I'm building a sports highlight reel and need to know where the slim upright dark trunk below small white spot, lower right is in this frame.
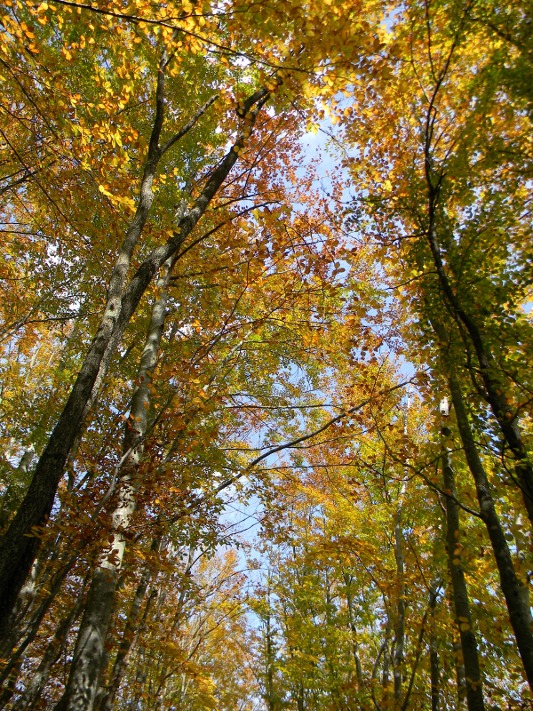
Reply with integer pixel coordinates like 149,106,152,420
442,427,485,711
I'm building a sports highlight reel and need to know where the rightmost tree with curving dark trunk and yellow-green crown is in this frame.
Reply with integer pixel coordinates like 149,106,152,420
340,3,533,696
